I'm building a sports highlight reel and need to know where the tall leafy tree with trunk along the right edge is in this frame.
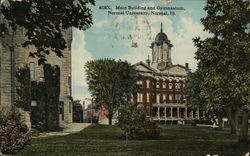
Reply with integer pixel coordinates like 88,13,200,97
194,0,250,143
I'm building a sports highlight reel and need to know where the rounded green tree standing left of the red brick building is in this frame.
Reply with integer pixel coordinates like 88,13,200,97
85,59,140,125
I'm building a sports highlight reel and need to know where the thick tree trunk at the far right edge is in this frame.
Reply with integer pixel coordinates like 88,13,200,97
239,109,249,143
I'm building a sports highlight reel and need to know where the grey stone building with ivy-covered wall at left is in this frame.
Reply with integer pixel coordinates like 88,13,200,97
0,28,72,122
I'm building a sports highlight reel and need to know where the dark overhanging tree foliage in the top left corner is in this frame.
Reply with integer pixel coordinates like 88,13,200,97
0,0,94,64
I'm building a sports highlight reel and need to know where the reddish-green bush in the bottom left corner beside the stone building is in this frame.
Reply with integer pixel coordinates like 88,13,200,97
0,120,29,153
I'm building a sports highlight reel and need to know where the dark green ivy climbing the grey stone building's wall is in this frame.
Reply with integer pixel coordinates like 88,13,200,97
16,64,60,131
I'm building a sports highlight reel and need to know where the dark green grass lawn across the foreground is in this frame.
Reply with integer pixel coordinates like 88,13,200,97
17,125,248,156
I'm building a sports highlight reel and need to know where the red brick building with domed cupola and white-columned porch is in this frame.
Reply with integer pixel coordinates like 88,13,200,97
132,25,205,123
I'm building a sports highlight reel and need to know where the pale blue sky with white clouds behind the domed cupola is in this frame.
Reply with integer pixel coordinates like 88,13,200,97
72,0,208,104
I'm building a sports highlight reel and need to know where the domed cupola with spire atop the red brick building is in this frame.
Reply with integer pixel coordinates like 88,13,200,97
150,23,173,71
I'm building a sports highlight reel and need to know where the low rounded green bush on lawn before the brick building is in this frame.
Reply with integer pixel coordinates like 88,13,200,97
118,104,160,139
